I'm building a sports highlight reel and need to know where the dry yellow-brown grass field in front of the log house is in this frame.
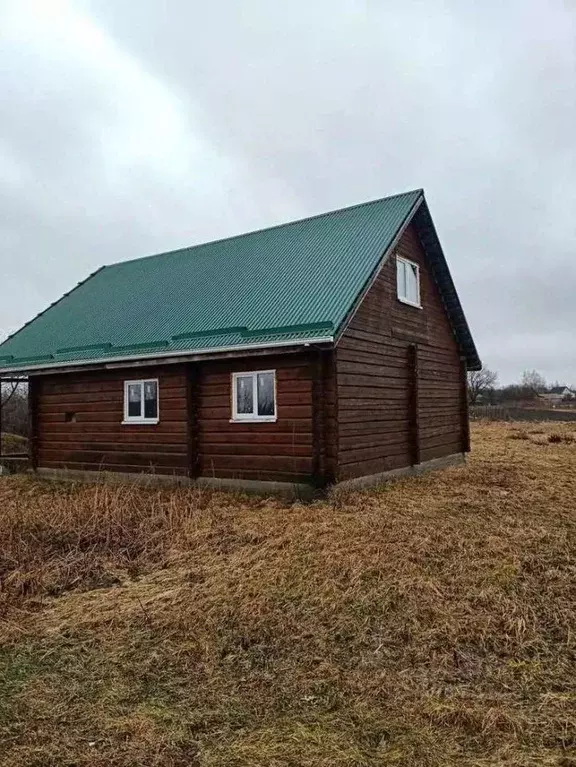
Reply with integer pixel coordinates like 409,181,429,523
0,423,576,767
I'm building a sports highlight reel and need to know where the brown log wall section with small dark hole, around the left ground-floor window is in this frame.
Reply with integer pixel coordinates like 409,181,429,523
31,365,188,474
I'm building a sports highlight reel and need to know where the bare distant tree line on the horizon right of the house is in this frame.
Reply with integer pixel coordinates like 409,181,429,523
468,368,576,405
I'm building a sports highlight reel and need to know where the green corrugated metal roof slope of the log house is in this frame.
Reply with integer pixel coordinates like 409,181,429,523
0,190,422,370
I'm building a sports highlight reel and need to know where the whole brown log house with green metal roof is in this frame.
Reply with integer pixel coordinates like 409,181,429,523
0,190,481,490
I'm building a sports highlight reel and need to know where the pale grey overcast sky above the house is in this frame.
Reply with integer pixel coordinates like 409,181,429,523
0,0,576,384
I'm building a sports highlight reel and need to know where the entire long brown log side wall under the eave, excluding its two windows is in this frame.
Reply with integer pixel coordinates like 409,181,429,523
34,352,322,482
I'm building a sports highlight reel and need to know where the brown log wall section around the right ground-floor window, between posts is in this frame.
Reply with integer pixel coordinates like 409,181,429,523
197,352,318,482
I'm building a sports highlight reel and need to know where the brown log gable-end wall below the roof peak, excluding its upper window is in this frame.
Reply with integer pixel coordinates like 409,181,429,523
336,219,467,479
